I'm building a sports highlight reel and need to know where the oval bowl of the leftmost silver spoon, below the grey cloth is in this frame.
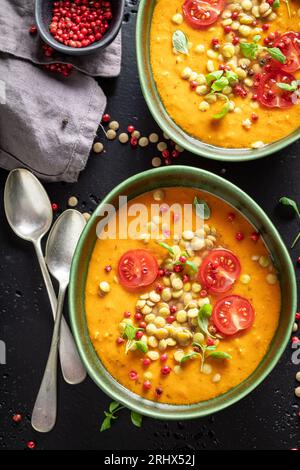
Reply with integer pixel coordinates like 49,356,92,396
4,168,53,242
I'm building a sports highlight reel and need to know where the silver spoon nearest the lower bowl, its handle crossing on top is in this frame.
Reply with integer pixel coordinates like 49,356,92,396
31,209,85,432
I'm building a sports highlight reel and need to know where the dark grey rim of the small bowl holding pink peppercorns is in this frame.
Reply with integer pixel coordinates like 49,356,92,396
34,0,125,56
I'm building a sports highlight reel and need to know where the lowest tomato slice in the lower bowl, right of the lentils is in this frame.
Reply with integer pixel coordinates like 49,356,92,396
212,295,255,336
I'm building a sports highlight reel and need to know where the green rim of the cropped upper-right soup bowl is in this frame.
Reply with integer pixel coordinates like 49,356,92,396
136,0,300,162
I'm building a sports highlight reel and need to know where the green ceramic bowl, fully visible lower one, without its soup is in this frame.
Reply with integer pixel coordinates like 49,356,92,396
69,166,296,419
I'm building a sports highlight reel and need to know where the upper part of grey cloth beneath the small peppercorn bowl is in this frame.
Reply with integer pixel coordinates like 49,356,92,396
0,0,121,77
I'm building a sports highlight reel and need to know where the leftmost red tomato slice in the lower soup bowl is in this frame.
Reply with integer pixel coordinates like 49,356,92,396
118,250,158,289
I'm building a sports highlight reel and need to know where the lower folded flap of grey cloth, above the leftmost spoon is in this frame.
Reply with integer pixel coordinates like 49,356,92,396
0,53,106,182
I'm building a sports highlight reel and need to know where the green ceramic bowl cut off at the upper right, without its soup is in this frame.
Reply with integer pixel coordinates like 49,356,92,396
136,0,300,162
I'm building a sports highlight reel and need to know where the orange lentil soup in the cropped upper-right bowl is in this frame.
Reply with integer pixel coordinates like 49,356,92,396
150,0,300,148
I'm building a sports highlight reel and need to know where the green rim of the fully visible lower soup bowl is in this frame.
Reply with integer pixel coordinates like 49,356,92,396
69,165,297,420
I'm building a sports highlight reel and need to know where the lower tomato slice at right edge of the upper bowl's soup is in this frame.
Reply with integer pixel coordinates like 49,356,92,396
257,68,295,108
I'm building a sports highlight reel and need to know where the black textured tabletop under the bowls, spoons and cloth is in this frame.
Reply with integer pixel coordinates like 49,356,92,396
0,0,300,450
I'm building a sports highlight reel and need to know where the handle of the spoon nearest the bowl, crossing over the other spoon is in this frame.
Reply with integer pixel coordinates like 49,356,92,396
31,287,66,432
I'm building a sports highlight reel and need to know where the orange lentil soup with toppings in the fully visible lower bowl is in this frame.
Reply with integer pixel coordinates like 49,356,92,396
85,188,281,404
